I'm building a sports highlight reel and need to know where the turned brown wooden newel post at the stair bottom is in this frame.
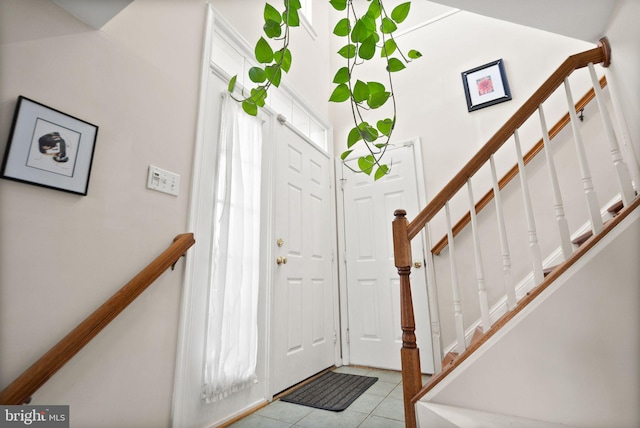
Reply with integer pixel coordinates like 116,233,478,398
393,210,422,428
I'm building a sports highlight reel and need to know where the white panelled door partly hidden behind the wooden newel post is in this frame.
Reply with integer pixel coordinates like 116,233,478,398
342,143,434,373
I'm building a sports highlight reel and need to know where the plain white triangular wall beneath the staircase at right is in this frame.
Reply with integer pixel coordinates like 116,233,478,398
425,209,640,428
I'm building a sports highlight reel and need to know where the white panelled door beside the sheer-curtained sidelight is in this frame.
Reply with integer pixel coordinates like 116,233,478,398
271,125,337,393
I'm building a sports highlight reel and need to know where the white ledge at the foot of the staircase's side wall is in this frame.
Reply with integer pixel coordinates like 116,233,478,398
416,401,567,428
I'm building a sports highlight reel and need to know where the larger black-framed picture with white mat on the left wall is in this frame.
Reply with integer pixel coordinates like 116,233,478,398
0,96,98,195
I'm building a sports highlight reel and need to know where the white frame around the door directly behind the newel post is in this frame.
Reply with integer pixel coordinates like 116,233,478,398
335,137,440,372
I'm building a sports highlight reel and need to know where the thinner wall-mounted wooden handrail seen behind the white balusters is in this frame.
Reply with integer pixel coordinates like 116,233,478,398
431,76,607,256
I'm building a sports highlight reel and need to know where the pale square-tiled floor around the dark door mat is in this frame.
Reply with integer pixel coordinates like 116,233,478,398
231,366,430,428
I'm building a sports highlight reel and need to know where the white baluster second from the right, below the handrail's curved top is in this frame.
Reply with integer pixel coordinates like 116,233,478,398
589,62,635,207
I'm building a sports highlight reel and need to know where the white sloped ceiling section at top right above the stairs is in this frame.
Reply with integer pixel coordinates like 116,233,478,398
422,0,617,42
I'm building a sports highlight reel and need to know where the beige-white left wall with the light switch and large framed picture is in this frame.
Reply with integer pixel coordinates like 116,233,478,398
0,0,205,427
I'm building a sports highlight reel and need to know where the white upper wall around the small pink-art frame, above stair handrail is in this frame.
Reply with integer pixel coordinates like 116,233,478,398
332,2,594,207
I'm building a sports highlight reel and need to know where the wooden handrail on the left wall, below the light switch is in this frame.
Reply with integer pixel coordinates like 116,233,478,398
0,233,196,404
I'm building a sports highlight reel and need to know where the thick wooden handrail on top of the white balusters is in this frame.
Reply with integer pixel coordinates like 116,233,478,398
407,37,611,240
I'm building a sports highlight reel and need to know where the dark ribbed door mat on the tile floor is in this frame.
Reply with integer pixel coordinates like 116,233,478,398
280,372,378,412
